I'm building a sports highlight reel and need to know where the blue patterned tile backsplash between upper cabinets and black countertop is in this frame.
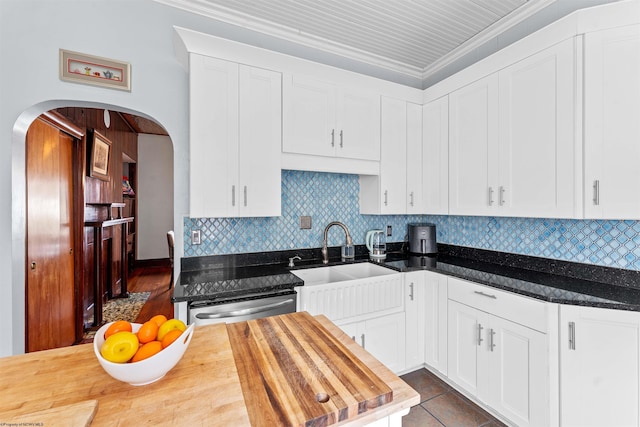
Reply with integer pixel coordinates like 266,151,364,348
184,170,640,270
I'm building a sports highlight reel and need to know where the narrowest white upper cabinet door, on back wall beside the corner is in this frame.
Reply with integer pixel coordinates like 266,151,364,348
408,102,422,214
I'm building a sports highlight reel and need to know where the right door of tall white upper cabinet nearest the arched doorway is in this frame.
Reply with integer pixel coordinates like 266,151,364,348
238,65,282,217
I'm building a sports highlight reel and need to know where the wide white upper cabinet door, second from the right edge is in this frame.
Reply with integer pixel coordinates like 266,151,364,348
495,39,578,218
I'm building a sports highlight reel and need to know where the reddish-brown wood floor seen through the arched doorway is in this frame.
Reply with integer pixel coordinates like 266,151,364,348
127,267,173,323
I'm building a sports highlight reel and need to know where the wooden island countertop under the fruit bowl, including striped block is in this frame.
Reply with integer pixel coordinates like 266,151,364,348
0,312,419,427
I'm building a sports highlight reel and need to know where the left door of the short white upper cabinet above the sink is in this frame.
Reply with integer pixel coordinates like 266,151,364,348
282,75,339,156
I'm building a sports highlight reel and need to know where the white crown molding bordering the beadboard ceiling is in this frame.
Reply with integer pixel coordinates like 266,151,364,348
154,0,557,80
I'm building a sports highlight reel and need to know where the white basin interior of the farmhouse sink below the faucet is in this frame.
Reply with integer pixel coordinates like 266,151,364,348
291,262,397,286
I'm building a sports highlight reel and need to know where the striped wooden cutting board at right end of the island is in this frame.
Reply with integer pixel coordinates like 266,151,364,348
227,312,393,427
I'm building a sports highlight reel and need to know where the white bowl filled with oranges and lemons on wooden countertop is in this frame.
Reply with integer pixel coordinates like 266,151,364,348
93,316,194,386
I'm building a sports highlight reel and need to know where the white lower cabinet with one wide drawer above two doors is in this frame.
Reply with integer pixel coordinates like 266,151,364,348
447,278,550,426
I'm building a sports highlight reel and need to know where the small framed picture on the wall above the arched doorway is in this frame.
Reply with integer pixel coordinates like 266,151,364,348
60,49,131,91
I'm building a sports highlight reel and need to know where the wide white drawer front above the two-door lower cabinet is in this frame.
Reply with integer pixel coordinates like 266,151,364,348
448,277,548,333
